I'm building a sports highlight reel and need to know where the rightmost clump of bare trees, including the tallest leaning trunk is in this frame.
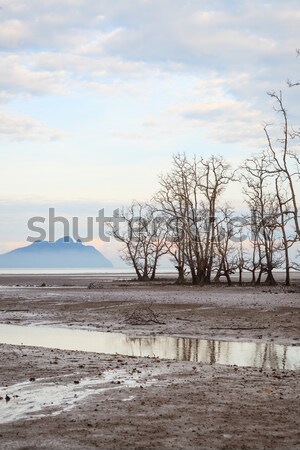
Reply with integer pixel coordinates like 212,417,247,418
242,93,300,285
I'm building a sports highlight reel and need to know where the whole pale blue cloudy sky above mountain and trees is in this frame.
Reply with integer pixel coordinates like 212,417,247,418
0,0,300,264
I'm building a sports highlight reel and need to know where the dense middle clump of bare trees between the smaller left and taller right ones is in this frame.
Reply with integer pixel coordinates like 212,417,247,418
154,155,234,285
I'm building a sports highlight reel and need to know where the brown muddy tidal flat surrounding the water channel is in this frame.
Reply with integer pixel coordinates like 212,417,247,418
0,276,300,450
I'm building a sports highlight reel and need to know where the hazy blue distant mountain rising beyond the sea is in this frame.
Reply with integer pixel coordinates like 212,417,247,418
0,236,113,269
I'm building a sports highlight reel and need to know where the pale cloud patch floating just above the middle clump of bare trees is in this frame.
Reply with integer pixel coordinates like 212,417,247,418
170,73,270,147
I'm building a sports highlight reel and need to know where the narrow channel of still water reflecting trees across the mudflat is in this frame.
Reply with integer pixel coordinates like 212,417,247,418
0,325,300,370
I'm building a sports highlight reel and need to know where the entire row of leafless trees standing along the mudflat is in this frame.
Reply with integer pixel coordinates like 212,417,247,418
111,67,300,285
